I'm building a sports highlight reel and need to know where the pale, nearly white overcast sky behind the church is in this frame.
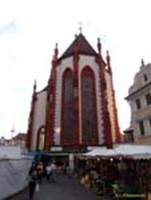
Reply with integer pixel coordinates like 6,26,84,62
0,0,151,138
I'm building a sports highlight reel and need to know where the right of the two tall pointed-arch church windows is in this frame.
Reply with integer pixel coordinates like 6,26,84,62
81,67,97,144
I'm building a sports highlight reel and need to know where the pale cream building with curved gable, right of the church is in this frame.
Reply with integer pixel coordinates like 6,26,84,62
126,60,151,144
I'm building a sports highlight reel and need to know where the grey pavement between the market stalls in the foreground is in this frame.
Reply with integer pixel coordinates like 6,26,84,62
9,174,109,200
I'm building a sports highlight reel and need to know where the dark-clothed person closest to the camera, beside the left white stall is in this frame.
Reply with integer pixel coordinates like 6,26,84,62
29,169,38,200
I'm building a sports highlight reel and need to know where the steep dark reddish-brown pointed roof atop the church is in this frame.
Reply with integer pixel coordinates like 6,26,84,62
60,33,97,59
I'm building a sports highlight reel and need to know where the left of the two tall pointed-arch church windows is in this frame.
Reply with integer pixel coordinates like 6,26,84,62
62,69,73,143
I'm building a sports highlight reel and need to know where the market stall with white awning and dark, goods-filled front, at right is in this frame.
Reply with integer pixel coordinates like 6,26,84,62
76,144,151,199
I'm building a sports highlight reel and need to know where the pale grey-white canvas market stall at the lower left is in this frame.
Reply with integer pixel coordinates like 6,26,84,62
0,146,33,200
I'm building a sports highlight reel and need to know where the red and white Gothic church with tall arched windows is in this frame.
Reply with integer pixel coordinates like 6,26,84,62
27,33,120,152
